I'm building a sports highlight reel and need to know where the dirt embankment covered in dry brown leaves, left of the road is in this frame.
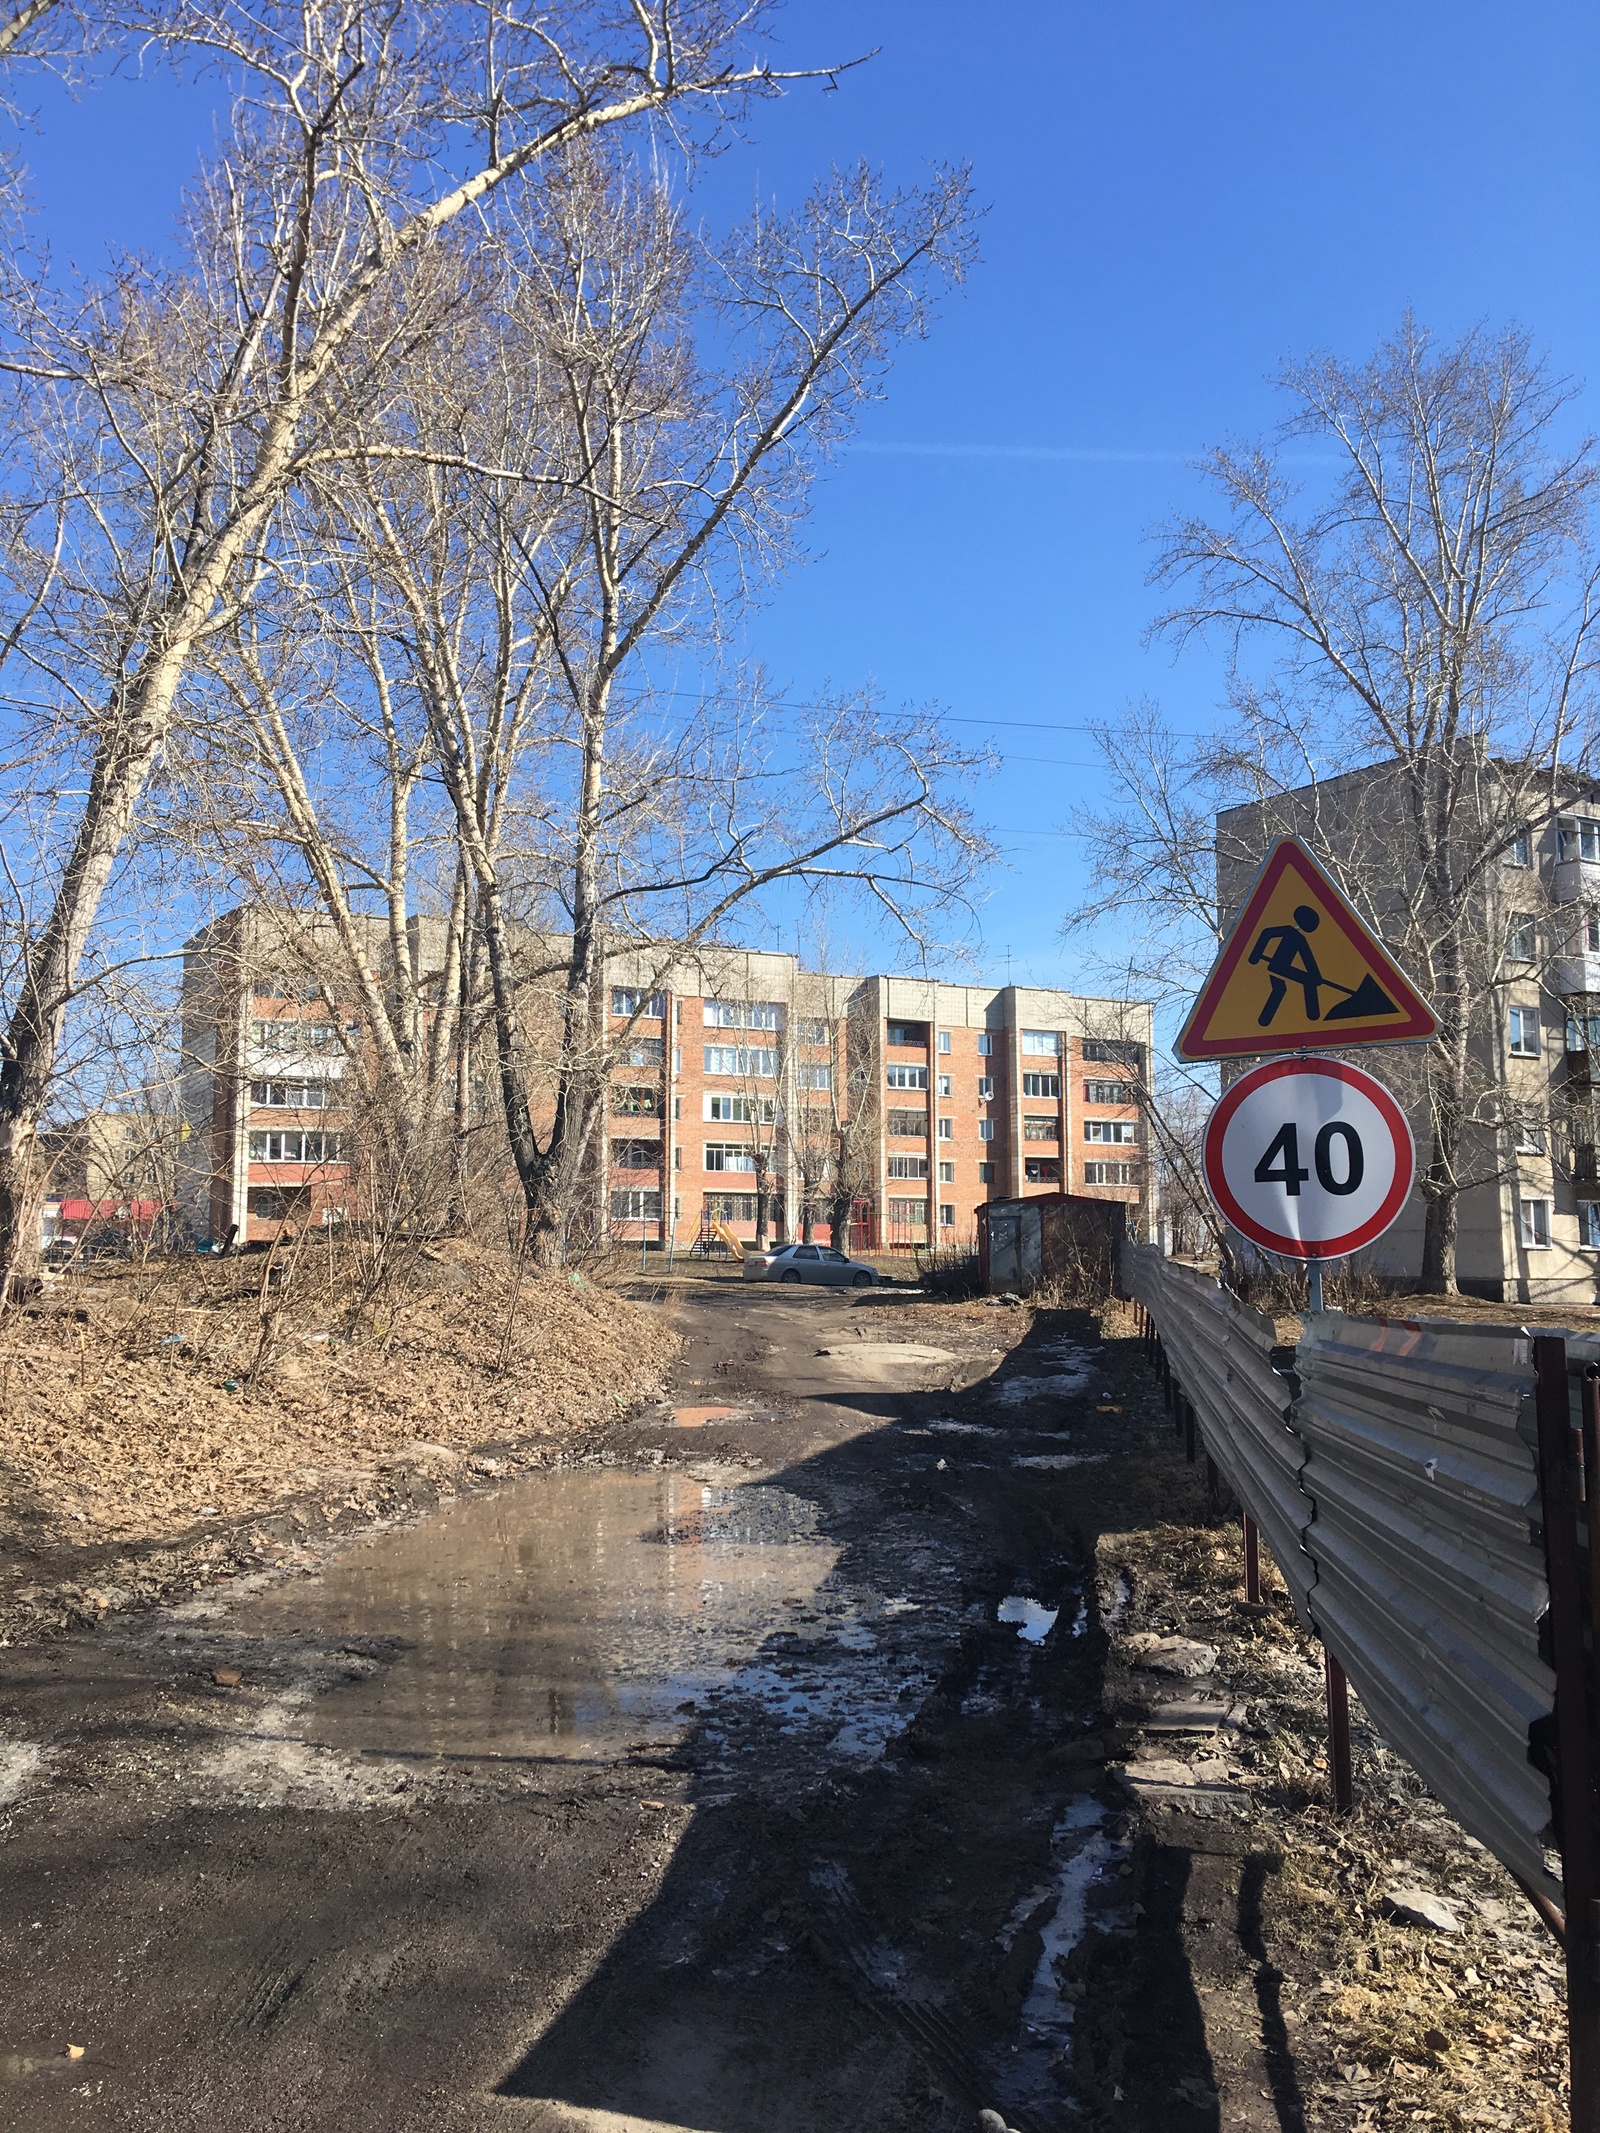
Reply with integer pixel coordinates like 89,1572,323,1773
0,1244,676,1640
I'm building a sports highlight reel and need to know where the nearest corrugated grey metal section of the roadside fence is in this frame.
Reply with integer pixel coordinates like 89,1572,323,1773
1293,1312,1562,1903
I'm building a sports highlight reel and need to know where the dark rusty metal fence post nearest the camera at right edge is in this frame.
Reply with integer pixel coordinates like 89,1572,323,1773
1534,1335,1600,2133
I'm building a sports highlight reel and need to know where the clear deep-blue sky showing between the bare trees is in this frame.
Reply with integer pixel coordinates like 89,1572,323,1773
23,0,1600,983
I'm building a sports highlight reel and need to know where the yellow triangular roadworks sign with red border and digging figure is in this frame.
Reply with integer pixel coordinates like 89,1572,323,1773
1175,836,1438,1060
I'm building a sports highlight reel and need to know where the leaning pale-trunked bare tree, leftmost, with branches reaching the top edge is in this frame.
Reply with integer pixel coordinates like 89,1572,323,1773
0,0,844,1299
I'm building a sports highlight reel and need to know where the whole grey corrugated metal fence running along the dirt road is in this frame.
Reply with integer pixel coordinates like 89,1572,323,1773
1122,1246,1562,1903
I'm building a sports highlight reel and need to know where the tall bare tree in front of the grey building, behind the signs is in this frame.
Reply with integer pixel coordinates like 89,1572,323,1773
1075,320,1600,1293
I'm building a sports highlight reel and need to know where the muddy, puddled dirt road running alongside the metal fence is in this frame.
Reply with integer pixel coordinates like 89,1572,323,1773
0,1280,1562,2133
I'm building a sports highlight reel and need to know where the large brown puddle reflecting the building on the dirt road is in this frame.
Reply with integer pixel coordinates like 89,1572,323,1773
233,1472,838,1760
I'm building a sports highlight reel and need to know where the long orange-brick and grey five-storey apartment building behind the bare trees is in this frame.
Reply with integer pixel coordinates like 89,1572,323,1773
172,911,1152,1250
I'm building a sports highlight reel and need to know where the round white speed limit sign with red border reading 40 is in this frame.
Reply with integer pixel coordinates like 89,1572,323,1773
1203,1058,1417,1258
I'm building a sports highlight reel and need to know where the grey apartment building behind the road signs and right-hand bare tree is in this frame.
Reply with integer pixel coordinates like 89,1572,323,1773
1216,764,1600,1305
